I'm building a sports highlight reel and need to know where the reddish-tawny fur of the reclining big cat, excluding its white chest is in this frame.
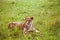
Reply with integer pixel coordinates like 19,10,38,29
8,17,33,32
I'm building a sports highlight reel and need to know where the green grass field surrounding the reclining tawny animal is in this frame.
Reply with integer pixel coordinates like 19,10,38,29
0,0,60,40
